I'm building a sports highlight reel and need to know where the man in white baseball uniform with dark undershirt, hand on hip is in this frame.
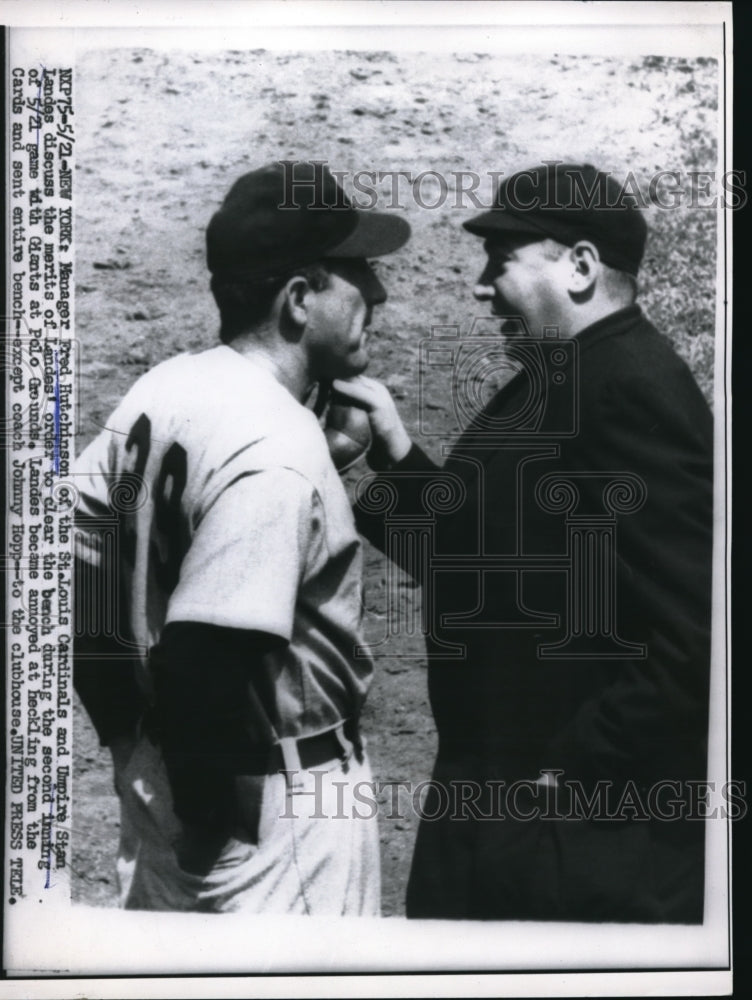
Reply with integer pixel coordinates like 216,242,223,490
75,162,409,915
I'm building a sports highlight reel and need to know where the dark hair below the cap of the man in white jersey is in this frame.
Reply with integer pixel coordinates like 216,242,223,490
210,263,329,344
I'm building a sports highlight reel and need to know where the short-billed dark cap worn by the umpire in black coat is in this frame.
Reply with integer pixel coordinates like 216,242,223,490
463,161,647,275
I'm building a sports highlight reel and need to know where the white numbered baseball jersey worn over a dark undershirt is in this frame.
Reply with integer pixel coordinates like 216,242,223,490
75,345,373,738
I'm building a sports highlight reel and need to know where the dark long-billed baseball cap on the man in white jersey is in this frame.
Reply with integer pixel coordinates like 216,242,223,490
206,160,410,280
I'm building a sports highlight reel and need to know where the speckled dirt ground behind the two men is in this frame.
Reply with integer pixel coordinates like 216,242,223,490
73,48,719,916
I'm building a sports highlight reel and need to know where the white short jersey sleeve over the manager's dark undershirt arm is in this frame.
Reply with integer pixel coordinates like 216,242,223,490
167,469,321,641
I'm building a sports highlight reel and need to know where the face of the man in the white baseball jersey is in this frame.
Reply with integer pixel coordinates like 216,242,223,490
303,259,386,380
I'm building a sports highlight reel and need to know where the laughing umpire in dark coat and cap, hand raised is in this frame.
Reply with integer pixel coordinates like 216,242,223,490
335,164,713,923
